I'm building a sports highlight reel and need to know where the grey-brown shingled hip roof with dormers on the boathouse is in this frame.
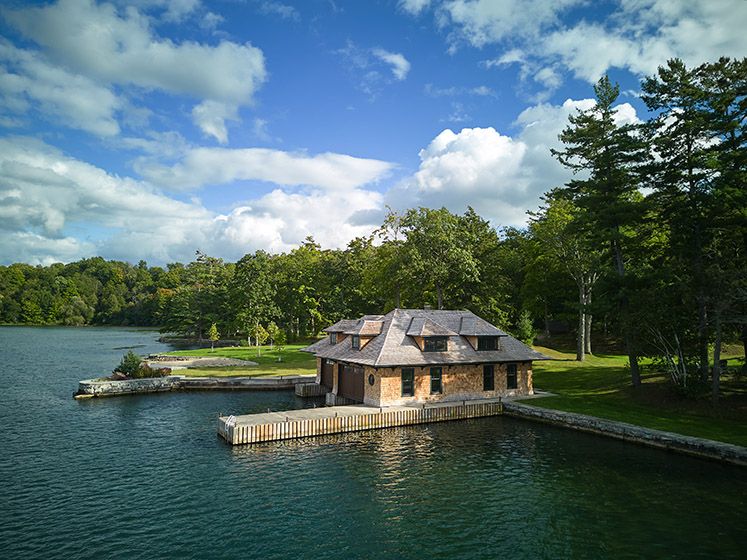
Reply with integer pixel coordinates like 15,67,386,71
303,309,548,367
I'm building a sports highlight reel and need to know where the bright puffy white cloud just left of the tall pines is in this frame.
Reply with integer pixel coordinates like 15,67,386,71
386,99,637,226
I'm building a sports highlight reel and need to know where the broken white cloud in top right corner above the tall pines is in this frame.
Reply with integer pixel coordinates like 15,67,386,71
437,0,747,89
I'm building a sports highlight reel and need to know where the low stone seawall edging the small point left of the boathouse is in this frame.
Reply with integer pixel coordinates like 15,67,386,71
75,375,315,398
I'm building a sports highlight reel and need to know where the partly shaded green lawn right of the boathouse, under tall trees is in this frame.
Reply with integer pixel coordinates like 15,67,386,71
525,347,747,447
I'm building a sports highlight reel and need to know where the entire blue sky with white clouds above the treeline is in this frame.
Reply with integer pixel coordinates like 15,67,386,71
0,0,747,265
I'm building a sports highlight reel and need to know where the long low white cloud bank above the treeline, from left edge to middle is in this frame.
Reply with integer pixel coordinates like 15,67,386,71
0,138,392,264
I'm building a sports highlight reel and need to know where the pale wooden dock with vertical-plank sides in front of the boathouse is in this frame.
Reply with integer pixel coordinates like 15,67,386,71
218,399,503,445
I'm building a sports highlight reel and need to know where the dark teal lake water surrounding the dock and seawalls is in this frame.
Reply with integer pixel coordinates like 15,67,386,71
0,327,747,559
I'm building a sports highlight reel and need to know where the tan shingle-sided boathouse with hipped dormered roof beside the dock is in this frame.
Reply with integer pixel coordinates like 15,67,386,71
304,309,547,406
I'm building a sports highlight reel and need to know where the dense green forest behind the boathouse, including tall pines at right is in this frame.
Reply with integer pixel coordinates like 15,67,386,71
0,54,747,391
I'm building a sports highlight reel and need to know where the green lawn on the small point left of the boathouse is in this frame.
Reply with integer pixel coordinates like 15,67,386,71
168,344,316,377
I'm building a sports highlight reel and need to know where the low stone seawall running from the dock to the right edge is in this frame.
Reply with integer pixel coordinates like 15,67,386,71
503,401,747,466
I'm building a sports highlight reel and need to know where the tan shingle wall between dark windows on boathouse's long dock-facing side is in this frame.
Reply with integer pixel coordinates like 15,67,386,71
363,362,533,406
